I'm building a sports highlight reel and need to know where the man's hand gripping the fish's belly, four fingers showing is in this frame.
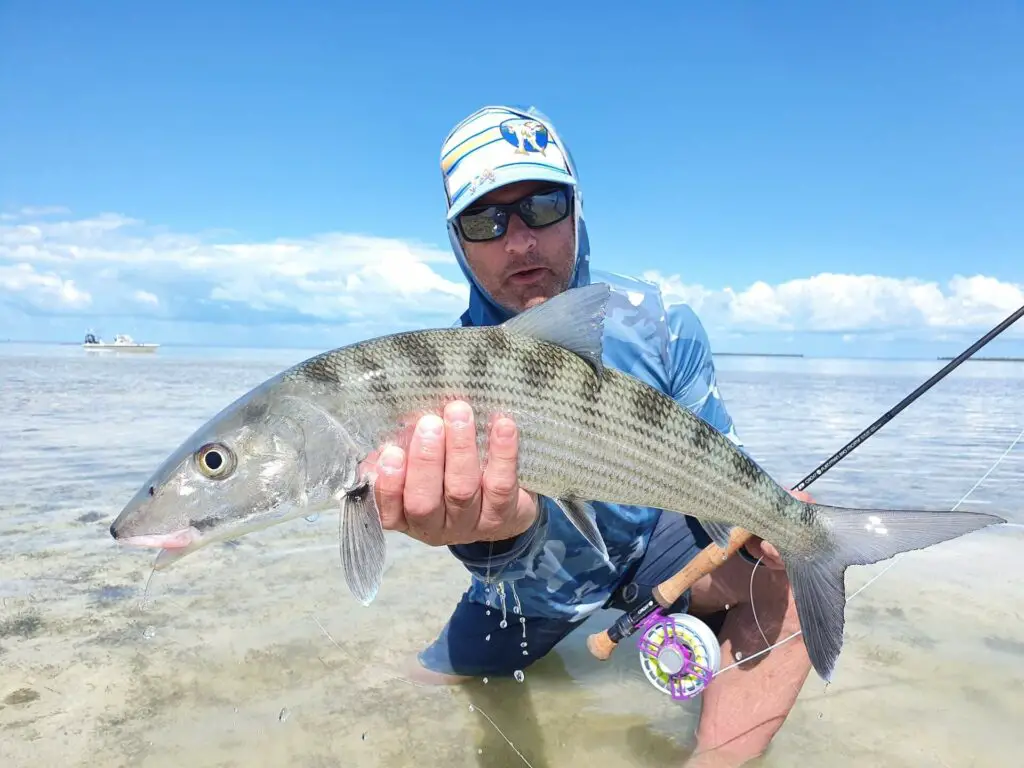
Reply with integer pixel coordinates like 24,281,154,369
371,401,538,546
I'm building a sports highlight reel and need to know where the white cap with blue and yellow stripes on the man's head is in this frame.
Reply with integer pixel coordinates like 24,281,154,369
440,106,577,221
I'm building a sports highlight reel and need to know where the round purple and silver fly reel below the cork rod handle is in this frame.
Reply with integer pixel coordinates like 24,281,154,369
637,609,722,701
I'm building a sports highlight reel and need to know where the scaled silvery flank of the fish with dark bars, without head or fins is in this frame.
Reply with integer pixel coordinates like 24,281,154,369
295,328,799,540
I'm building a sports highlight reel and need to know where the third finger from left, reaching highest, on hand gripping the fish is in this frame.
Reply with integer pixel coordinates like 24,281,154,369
444,401,480,535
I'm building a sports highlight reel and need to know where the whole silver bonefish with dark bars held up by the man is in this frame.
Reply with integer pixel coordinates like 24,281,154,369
111,284,1006,680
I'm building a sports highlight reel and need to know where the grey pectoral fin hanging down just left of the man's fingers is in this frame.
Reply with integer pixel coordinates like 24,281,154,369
338,481,387,605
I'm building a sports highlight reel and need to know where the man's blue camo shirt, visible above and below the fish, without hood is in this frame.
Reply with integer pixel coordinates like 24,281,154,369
450,273,741,621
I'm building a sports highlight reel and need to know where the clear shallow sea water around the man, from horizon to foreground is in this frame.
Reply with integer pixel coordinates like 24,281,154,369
0,344,1024,768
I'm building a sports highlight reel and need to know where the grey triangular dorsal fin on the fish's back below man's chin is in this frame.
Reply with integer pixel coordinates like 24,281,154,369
502,283,611,375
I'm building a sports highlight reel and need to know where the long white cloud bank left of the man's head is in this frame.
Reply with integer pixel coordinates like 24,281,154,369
0,208,468,333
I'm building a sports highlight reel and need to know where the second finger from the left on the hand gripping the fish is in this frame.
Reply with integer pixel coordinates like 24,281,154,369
403,414,444,544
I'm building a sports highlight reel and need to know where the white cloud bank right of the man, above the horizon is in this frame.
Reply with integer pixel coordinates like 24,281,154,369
644,271,1024,340
